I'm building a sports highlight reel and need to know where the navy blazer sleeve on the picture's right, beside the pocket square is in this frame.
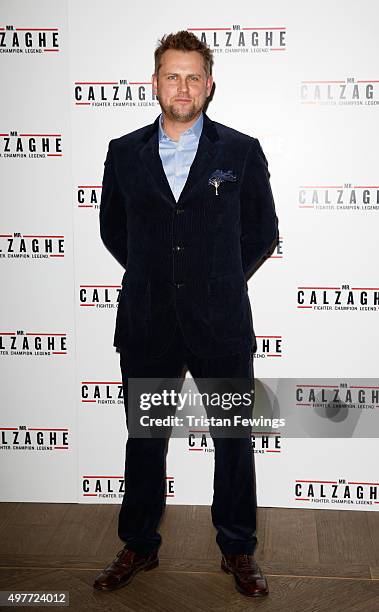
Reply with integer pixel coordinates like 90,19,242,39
241,138,279,278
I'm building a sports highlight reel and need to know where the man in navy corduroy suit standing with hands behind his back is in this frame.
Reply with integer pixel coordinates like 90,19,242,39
94,31,278,596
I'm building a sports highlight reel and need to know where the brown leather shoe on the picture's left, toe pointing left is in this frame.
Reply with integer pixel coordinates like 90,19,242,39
93,546,159,591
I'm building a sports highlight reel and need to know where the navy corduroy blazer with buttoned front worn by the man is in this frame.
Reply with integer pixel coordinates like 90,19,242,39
100,113,278,357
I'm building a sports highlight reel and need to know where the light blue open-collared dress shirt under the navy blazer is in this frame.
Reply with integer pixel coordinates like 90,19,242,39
159,113,204,201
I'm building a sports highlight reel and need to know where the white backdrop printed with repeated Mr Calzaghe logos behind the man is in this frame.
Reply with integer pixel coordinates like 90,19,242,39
0,0,379,510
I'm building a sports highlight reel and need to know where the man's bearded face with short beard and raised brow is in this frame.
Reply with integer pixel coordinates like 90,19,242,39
153,49,213,123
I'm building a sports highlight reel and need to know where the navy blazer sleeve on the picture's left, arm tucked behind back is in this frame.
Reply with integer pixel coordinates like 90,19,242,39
99,140,128,268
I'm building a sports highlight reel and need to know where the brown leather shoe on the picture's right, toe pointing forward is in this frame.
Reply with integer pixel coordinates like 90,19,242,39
221,555,268,597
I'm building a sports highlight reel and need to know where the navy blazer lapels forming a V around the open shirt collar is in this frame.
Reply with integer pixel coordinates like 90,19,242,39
139,113,219,208
